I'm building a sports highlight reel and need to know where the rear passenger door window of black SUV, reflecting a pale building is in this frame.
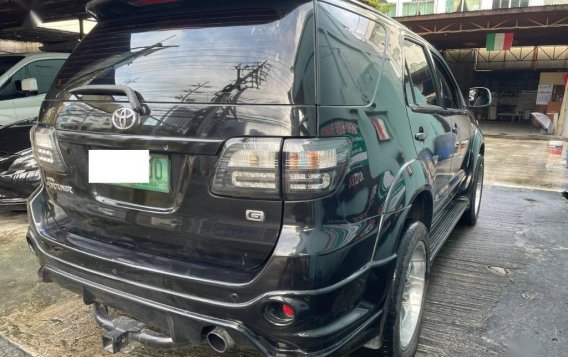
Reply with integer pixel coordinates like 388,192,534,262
404,40,438,105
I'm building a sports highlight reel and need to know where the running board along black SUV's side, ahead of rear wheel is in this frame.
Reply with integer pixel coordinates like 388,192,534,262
430,197,469,262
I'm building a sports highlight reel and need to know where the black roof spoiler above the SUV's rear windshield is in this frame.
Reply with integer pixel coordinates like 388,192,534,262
86,0,312,21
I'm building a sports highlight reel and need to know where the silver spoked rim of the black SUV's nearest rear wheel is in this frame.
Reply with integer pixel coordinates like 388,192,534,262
399,242,426,348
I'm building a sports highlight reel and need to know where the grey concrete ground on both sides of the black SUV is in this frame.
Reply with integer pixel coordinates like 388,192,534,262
0,137,568,357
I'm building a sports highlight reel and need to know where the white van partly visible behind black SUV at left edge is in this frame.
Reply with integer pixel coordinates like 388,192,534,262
0,53,69,126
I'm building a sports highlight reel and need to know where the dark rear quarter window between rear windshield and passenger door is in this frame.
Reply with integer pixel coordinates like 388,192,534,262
318,3,387,105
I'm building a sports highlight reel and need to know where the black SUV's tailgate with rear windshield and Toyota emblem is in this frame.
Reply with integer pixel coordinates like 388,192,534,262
40,2,316,272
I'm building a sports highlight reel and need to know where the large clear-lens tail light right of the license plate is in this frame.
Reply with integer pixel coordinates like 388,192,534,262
211,138,351,200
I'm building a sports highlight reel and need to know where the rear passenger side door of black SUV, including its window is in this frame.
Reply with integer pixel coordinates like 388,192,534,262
404,39,456,211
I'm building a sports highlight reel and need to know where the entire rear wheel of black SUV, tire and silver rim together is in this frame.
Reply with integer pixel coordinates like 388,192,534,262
355,221,429,357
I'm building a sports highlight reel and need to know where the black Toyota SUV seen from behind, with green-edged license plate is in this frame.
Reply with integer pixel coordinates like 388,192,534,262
28,0,491,356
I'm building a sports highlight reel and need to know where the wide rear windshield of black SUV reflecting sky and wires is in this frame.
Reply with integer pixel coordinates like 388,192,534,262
48,2,315,104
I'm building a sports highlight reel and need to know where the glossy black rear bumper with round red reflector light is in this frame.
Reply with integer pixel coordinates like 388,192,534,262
28,191,395,356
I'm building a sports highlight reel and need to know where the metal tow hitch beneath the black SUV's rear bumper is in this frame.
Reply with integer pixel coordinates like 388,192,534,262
94,303,188,353
